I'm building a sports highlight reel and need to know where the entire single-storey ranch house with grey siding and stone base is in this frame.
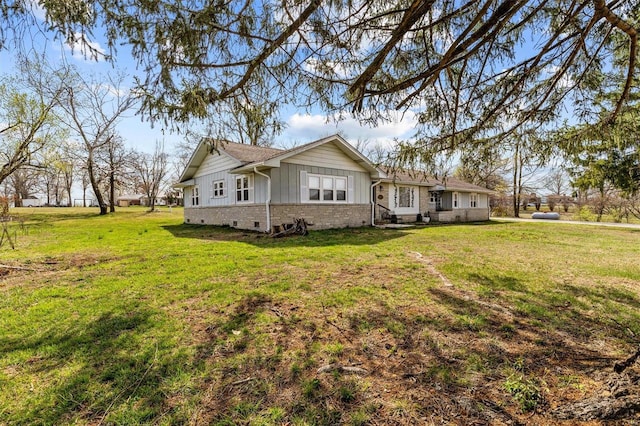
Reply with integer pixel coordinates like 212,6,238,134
174,135,490,232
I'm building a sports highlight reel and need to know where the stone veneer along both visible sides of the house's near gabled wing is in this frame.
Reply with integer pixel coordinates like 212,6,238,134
184,204,371,231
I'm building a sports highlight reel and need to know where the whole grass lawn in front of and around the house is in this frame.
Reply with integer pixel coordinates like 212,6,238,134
0,208,640,425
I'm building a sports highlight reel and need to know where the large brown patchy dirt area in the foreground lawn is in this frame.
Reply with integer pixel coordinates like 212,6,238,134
174,258,640,425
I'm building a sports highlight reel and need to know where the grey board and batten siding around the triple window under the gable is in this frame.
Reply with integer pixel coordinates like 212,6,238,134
271,159,371,204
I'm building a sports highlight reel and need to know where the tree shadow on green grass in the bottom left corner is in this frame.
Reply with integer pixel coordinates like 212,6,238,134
0,310,189,424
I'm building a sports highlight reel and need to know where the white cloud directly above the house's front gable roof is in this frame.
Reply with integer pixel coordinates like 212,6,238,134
281,111,417,148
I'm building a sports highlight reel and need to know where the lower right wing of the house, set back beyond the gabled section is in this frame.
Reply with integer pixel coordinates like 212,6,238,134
375,170,493,222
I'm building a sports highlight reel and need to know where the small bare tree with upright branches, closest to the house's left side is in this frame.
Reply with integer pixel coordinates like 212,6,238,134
131,141,168,211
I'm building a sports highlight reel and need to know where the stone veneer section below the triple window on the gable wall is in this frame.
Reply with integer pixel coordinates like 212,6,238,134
271,204,371,230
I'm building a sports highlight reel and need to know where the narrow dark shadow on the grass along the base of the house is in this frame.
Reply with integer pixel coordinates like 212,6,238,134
162,223,406,248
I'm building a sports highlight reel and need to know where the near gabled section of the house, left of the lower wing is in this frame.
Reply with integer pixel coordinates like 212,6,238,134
174,136,384,231
